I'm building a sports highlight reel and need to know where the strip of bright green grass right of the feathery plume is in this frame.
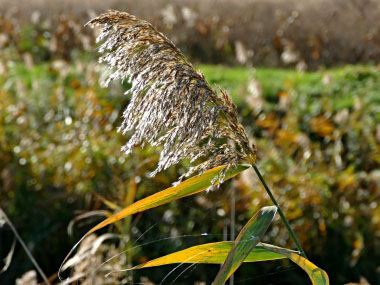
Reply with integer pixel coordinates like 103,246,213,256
198,65,380,118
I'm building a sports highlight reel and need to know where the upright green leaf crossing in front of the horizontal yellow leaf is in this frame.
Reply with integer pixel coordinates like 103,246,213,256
213,206,277,285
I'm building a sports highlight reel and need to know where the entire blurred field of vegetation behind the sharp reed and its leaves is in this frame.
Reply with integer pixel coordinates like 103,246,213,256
0,0,380,285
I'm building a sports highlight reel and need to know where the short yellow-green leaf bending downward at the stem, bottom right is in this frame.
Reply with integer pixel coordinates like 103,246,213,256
263,244,330,285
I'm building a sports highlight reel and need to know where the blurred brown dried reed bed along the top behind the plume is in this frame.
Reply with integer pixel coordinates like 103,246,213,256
0,0,380,69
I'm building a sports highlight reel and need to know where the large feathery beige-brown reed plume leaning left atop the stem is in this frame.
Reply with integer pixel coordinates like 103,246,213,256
88,10,256,181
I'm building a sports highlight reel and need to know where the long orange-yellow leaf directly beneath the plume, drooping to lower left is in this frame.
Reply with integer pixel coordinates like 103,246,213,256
58,165,250,276
